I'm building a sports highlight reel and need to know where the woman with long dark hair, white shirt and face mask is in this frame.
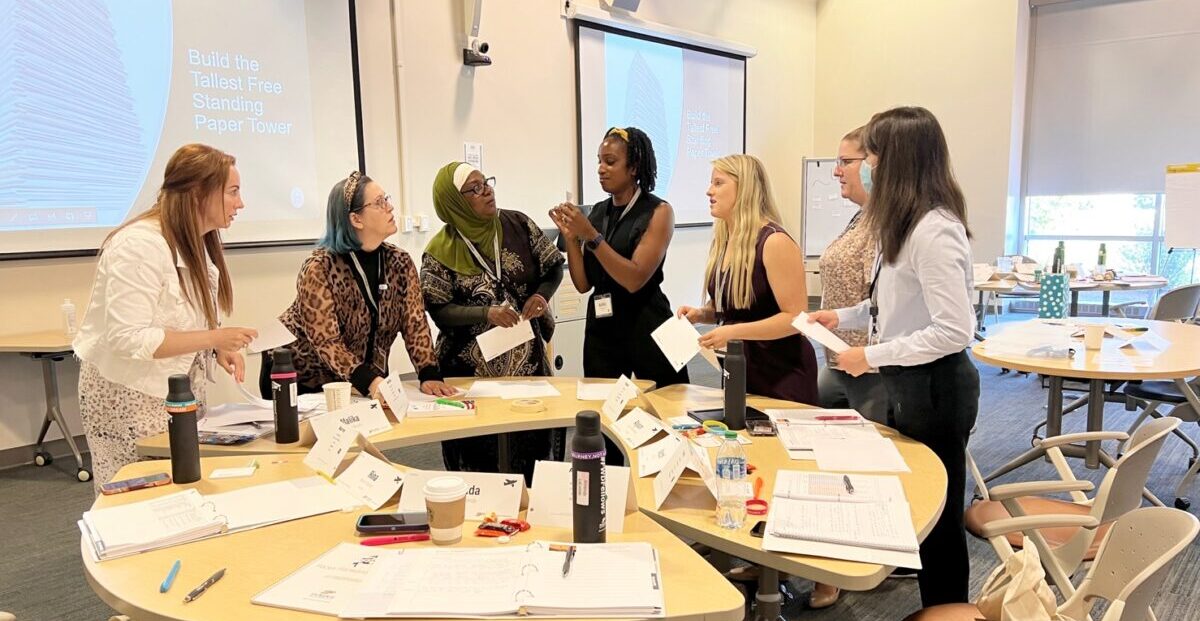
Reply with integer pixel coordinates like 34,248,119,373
810,108,979,608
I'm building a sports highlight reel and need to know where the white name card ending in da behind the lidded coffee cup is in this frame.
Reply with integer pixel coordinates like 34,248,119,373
397,470,529,520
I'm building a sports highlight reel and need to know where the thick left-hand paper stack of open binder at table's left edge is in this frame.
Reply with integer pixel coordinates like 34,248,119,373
79,489,226,561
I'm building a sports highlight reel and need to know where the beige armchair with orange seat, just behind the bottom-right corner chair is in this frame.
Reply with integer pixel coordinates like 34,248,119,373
965,418,1180,595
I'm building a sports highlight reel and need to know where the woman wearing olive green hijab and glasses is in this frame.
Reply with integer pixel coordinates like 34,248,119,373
421,162,565,483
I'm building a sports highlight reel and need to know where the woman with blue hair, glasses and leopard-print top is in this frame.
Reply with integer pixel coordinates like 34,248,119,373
270,171,455,397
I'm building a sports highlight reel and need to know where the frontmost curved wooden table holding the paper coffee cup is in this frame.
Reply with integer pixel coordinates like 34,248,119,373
80,454,744,621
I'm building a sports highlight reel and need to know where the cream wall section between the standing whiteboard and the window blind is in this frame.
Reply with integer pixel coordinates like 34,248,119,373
815,0,1028,261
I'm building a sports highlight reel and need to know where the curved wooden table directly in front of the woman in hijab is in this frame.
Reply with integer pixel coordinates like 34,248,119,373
137,378,654,457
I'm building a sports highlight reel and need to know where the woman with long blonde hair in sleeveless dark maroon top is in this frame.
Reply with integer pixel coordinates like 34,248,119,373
678,155,817,405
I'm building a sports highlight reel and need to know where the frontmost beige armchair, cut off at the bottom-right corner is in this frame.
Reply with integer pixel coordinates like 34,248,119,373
905,507,1200,621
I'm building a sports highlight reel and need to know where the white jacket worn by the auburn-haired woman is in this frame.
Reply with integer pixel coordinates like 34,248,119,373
73,219,220,398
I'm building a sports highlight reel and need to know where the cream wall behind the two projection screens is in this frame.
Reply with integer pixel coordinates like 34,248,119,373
0,0,827,450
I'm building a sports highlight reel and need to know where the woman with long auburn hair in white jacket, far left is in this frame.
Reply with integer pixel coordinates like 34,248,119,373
73,144,258,492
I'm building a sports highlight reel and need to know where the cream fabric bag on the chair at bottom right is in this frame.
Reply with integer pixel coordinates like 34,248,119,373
976,538,1070,621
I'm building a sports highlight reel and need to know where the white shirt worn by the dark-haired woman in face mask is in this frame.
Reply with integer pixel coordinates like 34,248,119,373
838,209,976,368
